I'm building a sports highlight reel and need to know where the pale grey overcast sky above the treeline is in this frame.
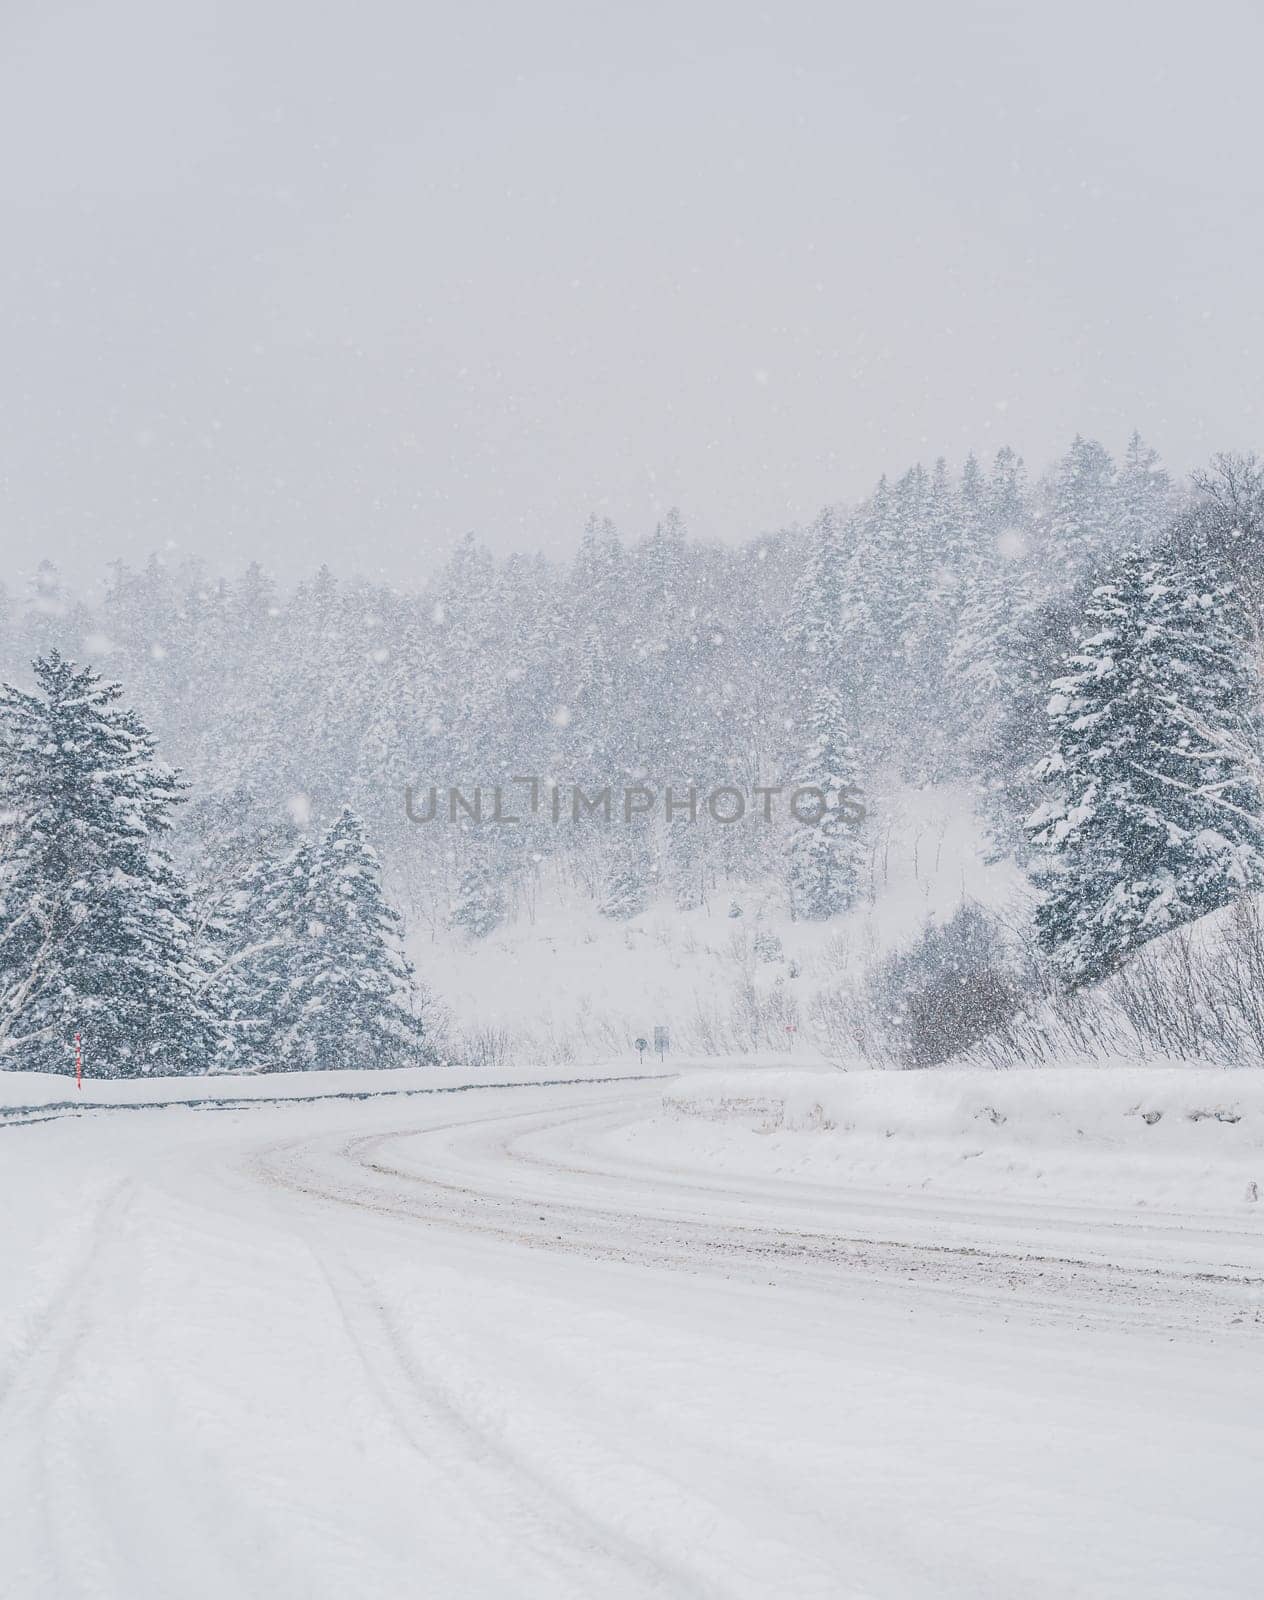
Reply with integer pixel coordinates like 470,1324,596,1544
0,0,1264,582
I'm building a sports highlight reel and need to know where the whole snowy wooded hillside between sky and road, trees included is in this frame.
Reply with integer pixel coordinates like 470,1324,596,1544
0,434,1264,1077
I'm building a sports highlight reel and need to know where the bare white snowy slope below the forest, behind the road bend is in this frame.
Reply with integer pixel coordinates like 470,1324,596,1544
411,787,1029,1064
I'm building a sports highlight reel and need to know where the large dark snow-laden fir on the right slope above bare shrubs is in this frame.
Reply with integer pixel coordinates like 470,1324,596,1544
1027,555,1264,984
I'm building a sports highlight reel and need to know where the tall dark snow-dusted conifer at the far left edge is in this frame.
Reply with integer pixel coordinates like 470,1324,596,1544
0,650,218,1077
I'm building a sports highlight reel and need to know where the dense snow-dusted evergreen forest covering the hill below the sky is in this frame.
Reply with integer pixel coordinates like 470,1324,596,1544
0,435,1264,1066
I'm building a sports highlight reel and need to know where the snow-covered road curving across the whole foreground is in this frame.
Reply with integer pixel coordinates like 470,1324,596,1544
0,1083,1264,1600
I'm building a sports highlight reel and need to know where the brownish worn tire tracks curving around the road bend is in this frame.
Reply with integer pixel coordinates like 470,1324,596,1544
259,1099,1264,1328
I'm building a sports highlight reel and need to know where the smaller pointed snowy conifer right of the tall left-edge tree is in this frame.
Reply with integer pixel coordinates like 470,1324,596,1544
275,808,435,1069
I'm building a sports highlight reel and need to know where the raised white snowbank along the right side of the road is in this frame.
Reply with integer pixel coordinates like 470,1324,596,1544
659,1064,1264,1203
